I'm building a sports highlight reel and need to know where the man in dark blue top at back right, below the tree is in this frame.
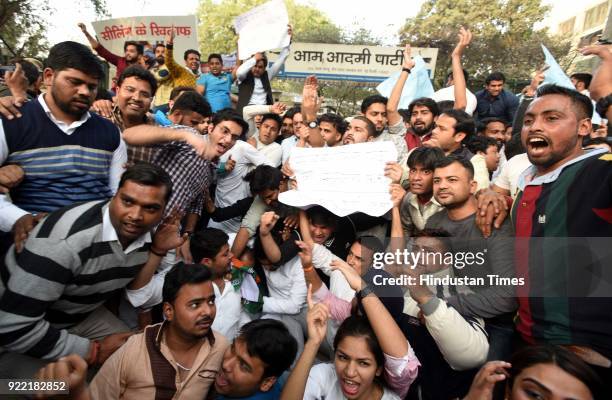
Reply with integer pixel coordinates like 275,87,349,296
474,72,519,124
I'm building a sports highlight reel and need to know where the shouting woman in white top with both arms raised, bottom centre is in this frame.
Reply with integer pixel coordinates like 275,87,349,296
281,262,419,400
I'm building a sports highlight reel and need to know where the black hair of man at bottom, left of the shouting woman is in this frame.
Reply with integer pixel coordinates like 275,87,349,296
235,319,297,378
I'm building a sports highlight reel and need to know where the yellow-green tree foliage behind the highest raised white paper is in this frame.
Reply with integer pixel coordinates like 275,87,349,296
198,0,343,55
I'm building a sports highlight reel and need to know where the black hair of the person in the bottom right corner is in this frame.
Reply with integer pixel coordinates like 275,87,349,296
506,344,603,399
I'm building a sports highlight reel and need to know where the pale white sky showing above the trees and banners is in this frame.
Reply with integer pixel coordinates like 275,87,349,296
47,0,584,45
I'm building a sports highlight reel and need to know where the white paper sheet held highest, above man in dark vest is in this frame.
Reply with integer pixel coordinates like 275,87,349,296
234,0,290,60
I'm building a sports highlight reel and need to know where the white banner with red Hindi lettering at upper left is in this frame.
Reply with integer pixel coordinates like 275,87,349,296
91,15,200,65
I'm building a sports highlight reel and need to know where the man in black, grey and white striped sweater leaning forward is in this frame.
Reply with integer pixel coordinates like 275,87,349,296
0,163,185,378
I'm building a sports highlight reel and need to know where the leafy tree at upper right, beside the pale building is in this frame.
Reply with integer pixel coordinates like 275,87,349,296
400,0,570,89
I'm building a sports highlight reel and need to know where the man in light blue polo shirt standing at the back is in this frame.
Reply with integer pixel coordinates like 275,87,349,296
197,53,234,113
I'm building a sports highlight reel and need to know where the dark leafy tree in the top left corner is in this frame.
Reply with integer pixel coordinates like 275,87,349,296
0,0,106,58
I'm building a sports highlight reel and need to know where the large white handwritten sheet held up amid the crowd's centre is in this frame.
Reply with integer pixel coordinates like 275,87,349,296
278,142,397,217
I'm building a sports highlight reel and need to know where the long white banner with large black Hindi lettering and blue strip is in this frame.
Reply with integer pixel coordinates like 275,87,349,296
268,43,438,82
